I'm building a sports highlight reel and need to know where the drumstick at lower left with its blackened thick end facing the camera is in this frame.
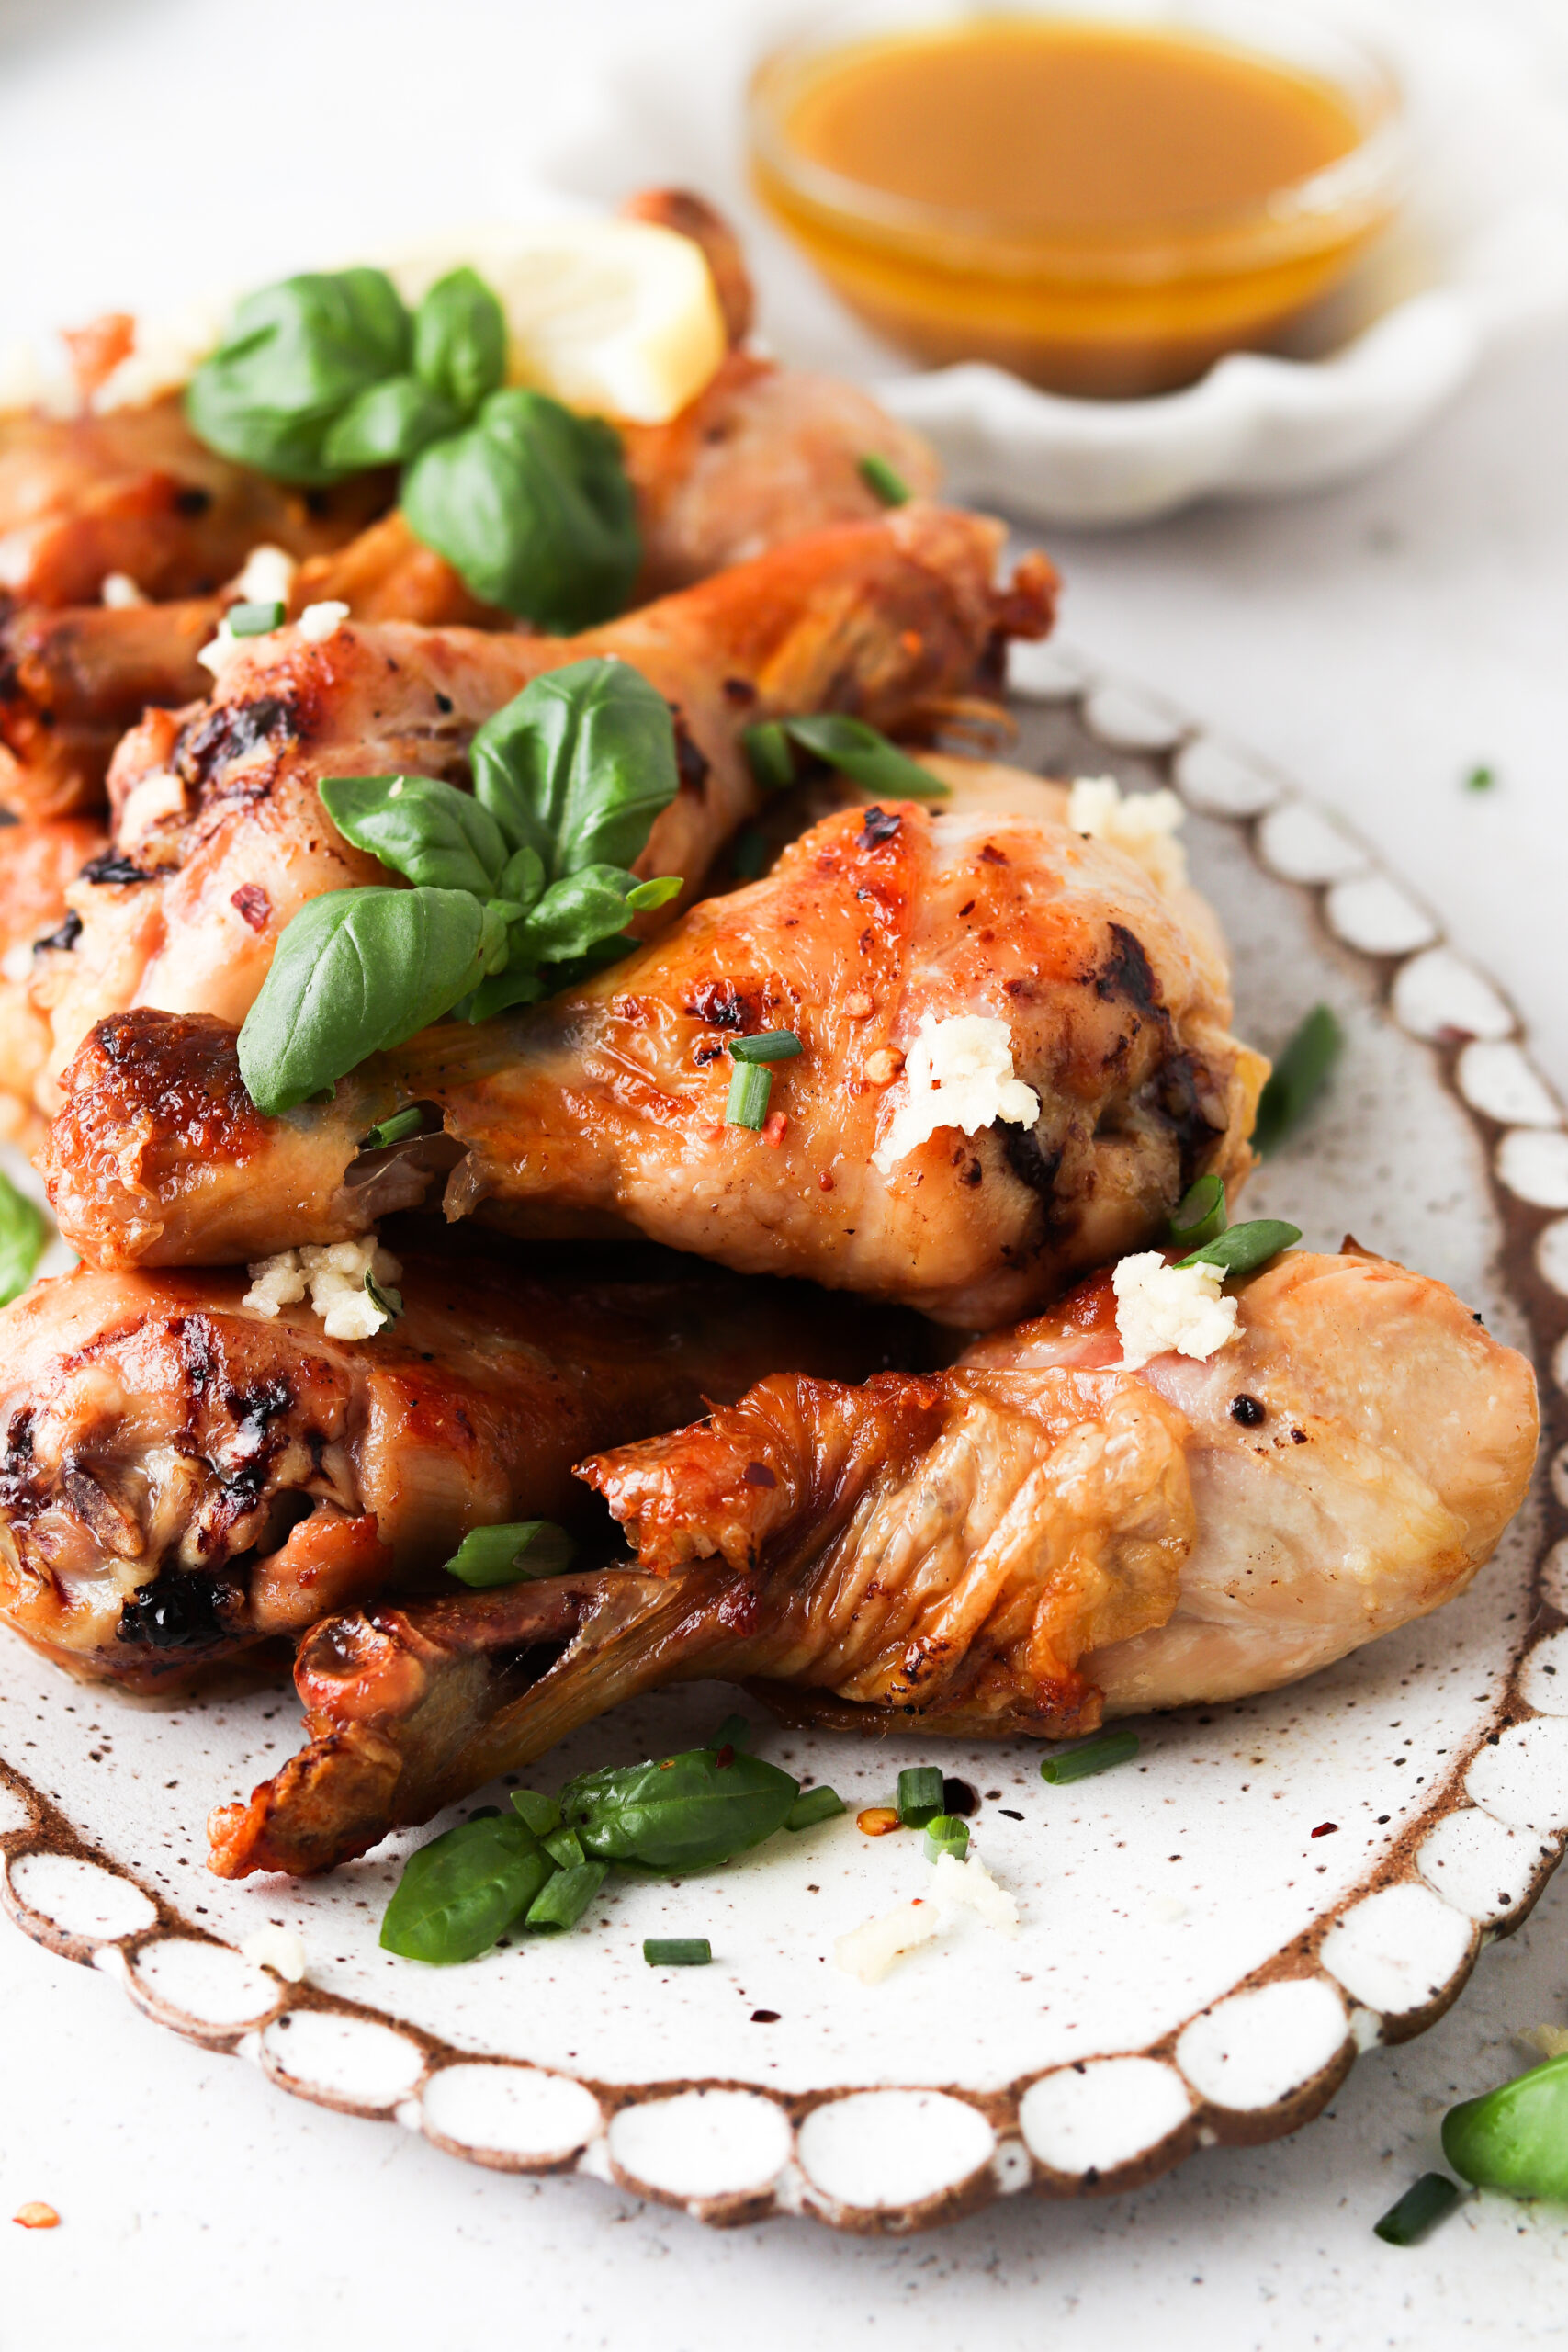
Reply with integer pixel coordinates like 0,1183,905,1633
0,1249,896,1689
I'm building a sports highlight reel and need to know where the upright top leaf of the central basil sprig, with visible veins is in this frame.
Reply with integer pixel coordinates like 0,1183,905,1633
470,661,680,882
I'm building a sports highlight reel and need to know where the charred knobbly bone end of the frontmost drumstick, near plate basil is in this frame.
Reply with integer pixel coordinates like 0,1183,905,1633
207,1724,402,1879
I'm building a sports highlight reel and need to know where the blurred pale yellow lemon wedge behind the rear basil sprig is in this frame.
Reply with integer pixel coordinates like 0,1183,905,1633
388,221,724,425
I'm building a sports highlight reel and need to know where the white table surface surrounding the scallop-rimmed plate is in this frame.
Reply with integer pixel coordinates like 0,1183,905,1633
0,0,1568,2352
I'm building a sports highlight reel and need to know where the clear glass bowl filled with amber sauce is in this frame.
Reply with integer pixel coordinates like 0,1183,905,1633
750,7,1404,398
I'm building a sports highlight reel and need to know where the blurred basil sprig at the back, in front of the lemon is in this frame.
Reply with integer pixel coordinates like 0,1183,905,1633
186,268,642,635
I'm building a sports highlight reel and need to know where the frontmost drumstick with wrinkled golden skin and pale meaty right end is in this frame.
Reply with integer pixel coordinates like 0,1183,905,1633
209,1249,1538,1877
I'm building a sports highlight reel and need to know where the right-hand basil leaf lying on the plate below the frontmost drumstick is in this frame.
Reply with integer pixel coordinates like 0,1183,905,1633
562,1747,799,1872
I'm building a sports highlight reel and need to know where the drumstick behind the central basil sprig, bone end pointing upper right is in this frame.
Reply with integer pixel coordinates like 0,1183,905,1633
33,505,1054,1110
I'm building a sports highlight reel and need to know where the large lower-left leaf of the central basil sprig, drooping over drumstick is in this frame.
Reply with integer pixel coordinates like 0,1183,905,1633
240,887,505,1114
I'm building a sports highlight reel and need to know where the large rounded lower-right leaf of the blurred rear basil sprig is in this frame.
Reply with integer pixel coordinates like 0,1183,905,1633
402,390,642,635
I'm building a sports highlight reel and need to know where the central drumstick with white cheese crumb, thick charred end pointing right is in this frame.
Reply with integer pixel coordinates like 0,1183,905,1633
50,778,1265,1329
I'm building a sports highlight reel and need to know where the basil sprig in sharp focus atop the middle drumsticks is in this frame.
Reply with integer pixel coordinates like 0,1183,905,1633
240,661,682,1114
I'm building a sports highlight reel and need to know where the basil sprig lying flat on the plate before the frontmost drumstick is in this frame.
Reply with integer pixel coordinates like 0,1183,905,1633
381,1721,844,1964
